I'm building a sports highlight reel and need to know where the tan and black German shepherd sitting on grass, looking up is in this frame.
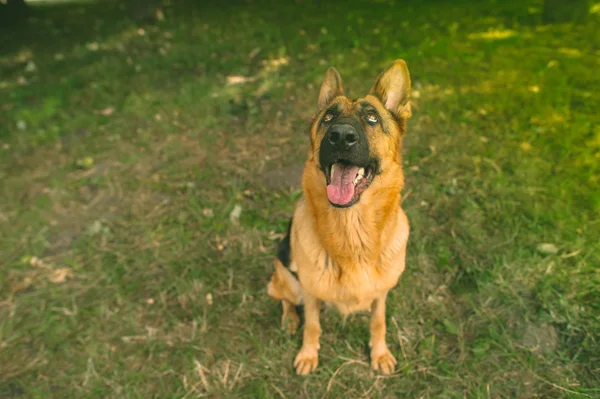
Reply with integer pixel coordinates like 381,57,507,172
268,60,411,375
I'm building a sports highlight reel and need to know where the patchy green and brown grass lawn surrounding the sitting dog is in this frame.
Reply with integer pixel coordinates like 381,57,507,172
0,1,600,398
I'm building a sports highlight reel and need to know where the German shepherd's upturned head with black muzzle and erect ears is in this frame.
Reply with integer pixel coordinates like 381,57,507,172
310,60,411,208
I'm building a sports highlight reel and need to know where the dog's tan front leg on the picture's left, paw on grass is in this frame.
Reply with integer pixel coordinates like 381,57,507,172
294,292,321,375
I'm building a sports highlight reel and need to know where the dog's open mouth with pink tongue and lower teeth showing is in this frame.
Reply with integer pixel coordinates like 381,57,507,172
325,161,375,208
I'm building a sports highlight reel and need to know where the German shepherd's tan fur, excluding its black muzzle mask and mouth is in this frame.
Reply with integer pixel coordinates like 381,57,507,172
268,60,411,374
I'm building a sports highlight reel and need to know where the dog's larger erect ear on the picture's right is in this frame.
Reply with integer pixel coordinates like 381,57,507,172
370,60,411,118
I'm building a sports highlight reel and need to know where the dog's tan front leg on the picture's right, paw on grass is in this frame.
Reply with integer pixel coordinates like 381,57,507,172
369,292,397,374
